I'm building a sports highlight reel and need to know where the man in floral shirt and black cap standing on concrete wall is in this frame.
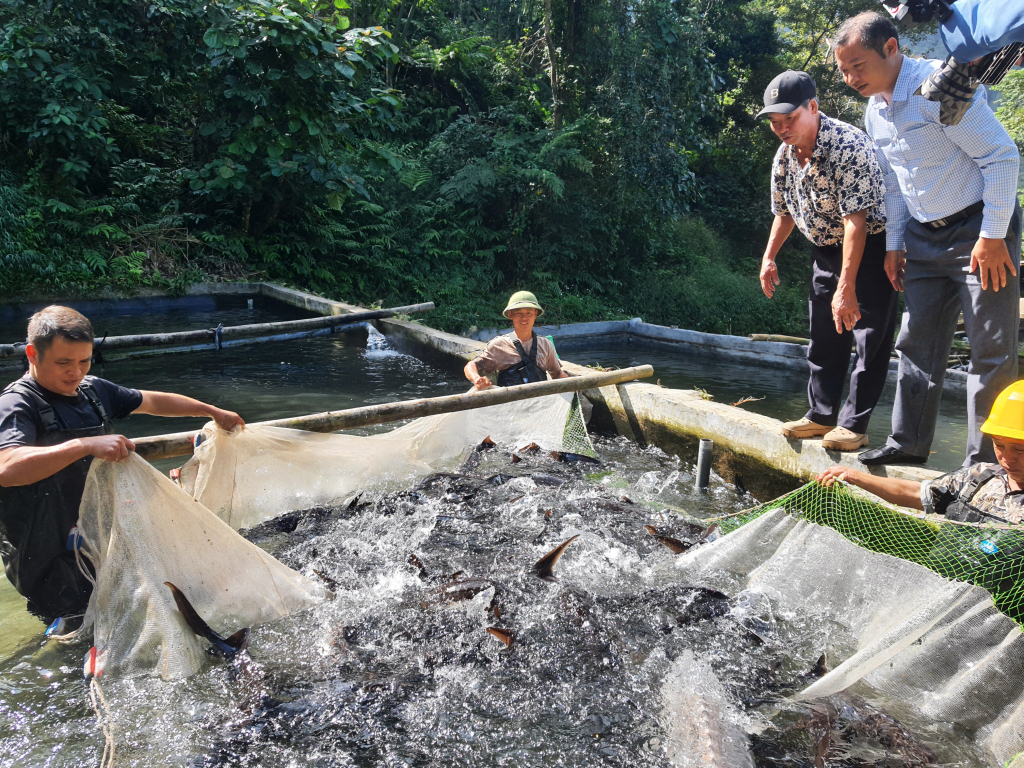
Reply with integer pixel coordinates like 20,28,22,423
758,71,896,451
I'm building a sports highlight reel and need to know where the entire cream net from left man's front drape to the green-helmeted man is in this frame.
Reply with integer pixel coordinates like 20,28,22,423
61,394,593,679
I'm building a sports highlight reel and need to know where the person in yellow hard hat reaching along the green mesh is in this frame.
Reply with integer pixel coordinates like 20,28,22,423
817,381,1024,523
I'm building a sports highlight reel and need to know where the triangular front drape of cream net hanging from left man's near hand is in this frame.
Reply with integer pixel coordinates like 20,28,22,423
78,455,325,679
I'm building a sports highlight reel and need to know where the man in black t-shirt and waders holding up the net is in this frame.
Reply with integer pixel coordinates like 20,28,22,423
0,306,244,621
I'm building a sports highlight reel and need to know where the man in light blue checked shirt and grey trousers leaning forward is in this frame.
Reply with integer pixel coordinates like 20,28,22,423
833,12,1021,466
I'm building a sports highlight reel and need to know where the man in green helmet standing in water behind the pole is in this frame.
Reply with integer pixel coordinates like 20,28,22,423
464,291,568,389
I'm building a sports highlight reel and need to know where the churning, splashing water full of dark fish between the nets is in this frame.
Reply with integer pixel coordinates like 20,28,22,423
0,439,983,768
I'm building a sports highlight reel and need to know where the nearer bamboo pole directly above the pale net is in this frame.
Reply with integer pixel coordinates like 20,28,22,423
133,366,654,461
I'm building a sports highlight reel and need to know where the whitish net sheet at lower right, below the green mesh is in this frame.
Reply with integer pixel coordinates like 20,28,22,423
674,510,1024,765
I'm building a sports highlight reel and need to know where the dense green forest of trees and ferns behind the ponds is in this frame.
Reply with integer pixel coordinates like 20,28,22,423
0,0,1024,335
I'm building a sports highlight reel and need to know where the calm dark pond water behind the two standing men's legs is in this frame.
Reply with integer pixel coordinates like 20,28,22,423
558,343,967,472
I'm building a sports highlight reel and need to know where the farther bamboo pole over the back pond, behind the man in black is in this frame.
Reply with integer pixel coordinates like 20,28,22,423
0,301,434,357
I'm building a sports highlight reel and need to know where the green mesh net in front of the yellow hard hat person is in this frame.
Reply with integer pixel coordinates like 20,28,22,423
719,482,1024,626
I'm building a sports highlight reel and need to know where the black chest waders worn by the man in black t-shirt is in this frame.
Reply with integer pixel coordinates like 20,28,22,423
0,380,114,621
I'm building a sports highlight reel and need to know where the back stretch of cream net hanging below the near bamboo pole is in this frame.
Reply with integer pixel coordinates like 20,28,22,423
181,394,593,529
